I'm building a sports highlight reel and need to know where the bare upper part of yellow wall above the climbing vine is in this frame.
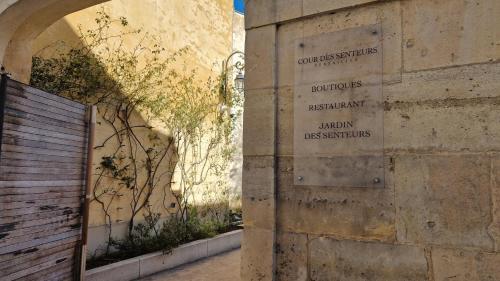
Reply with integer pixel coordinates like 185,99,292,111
33,0,233,81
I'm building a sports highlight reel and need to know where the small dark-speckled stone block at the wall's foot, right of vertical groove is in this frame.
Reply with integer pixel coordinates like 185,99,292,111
276,232,308,281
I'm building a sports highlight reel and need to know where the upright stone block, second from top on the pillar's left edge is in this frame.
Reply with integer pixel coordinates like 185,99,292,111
245,25,276,91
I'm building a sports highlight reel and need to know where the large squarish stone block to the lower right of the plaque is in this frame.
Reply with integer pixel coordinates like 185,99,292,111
394,155,493,250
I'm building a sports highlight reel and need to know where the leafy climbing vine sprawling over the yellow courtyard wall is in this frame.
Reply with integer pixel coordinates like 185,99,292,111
31,10,241,252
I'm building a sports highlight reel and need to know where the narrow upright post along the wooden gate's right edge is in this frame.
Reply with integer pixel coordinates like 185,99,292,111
80,105,97,281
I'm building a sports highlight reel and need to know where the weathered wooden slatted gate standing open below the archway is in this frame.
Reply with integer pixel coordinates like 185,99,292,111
0,75,93,280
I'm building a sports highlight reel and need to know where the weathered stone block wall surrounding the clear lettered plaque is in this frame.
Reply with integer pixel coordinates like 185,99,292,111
242,0,500,281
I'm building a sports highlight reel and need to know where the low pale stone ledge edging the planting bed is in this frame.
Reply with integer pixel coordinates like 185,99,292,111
85,230,243,281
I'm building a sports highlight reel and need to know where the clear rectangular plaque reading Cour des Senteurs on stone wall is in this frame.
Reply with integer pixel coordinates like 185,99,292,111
294,25,384,187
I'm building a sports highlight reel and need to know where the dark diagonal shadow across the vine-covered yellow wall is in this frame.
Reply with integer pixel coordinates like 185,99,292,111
30,16,177,255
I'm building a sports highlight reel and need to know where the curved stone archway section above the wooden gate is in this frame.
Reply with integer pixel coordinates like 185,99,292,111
0,0,108,82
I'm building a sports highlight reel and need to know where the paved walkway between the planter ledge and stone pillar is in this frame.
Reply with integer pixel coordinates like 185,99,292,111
140,249,241,281
